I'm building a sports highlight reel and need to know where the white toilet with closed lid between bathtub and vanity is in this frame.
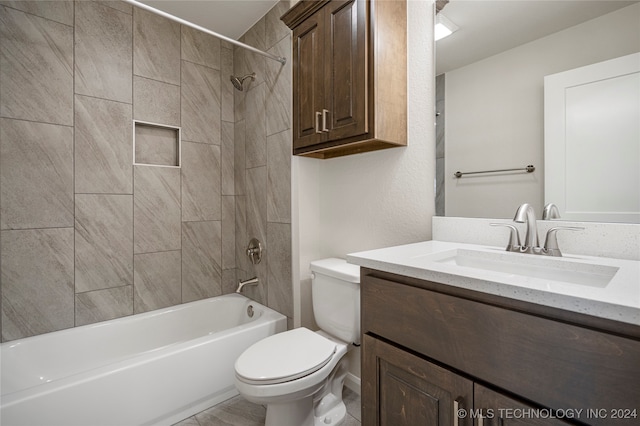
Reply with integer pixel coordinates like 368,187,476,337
235,258,360,426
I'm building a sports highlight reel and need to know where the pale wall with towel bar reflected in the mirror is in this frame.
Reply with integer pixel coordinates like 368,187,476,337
445,4,640,218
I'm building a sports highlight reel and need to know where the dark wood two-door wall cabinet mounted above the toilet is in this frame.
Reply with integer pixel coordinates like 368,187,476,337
282,0,407,158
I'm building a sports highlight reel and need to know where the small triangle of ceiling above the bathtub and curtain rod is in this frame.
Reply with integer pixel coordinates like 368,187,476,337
142,0,278,40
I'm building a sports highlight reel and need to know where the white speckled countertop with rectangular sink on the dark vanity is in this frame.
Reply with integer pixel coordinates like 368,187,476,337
347,241,640,325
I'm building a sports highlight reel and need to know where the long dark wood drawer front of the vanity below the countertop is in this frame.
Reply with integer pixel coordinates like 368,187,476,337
361,275,640,424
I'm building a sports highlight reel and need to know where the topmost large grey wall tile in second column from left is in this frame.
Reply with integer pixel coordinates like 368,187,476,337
75,1,133,103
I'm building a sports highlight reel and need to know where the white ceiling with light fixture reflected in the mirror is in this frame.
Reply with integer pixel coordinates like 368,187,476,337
436,0,637,74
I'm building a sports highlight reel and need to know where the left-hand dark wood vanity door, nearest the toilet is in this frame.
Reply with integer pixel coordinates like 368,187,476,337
362,335,473,426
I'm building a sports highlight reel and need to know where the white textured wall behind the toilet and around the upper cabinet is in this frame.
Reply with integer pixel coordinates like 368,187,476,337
292,0,435,388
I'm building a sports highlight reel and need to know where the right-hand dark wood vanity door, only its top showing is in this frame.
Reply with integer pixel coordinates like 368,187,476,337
473,383,573,426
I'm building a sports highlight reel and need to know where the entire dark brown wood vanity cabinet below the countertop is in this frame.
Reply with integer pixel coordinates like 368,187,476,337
361,268,640,426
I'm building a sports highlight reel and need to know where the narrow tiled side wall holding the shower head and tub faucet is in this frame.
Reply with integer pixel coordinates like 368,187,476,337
233,0,293,324
